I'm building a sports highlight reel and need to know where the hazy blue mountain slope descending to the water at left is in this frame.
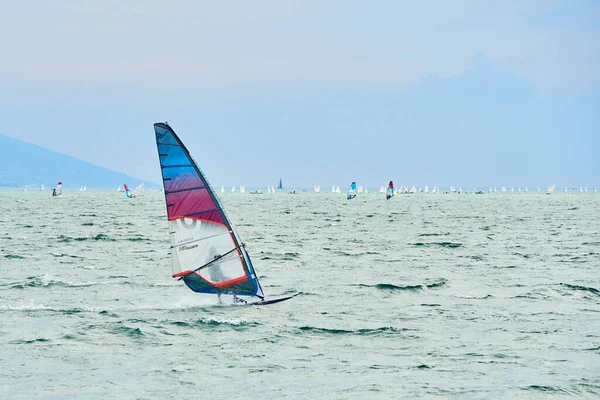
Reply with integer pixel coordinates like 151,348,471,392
0,135,157,189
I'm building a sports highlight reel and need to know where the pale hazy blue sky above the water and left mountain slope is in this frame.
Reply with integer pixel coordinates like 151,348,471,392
0,0,600,187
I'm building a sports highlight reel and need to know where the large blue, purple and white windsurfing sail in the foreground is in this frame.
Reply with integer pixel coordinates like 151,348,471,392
154,123,264,299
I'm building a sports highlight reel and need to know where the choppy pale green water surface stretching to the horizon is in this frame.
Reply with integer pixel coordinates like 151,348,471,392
0,189,600,399
